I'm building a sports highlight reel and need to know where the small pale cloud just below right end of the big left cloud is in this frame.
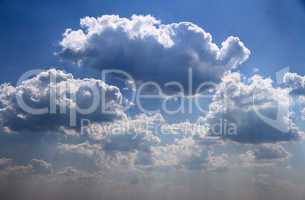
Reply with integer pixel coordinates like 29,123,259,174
83,114,165,151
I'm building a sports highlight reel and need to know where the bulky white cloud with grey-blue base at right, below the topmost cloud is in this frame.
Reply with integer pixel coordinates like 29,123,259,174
204,73,300,143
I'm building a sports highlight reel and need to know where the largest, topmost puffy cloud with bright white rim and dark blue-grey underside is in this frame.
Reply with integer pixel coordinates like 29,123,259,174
58,15,250,89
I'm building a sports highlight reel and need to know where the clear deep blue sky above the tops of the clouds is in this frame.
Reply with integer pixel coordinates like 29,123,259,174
0,0,305,82
